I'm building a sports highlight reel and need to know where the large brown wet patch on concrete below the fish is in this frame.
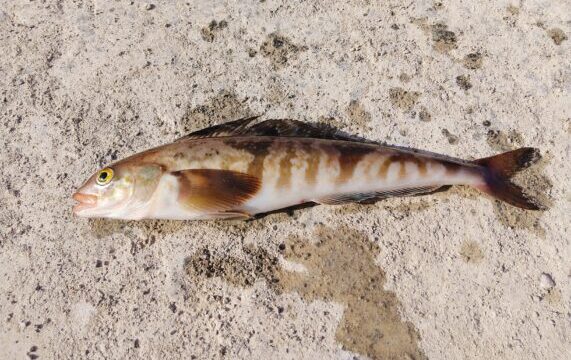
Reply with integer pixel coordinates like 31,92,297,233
185,227,426,359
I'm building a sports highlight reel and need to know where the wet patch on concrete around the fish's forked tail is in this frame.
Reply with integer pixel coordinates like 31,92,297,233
487,130,553,238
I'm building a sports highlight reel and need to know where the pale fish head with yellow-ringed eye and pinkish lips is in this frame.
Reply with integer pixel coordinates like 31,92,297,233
73,162,163,219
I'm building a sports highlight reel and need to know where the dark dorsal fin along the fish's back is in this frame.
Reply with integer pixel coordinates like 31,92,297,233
177,116,375,143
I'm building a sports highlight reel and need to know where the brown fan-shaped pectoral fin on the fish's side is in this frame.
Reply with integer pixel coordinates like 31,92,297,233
172,169,261,217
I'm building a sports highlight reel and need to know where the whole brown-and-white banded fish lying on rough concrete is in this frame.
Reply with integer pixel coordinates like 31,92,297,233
73,116,544,220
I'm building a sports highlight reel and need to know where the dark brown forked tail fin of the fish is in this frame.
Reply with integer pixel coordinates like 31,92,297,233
474,148,545,210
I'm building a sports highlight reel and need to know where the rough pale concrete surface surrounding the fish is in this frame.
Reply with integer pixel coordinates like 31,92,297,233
0,0,571,359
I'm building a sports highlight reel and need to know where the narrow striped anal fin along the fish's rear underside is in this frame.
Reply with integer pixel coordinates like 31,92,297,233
313,185,441,205
